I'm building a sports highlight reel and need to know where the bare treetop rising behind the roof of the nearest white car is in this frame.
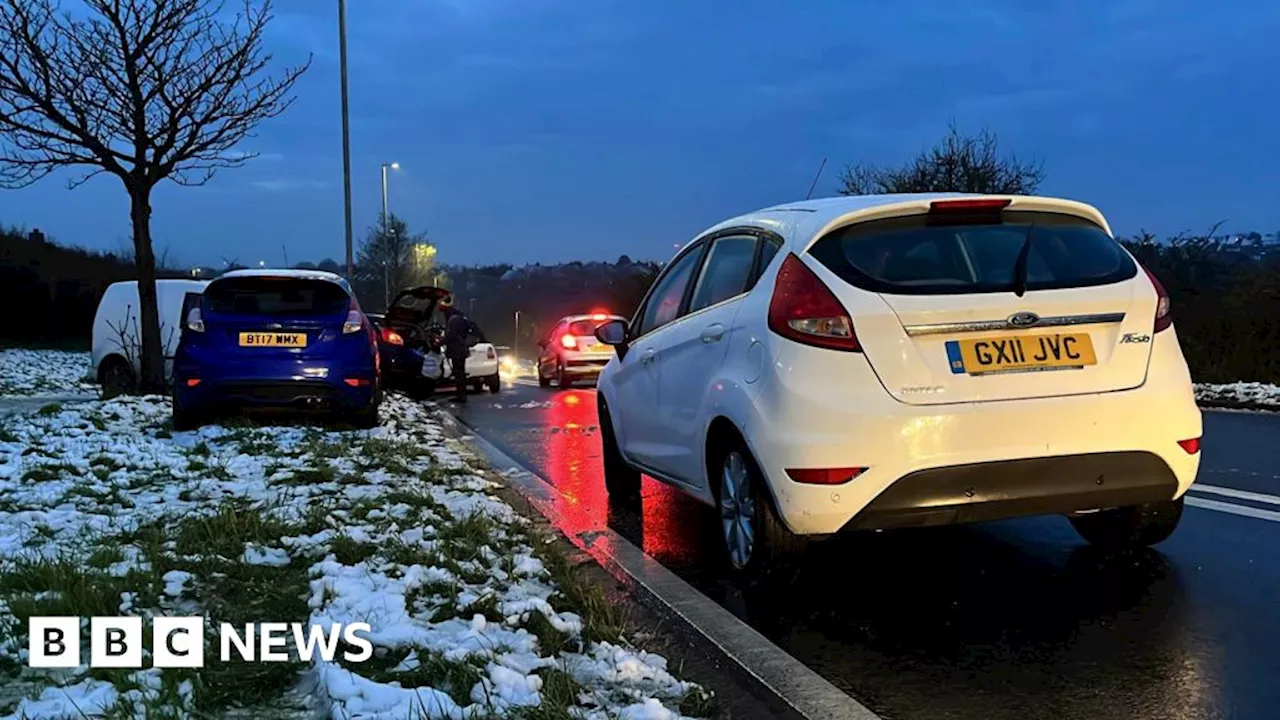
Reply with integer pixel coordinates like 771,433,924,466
840,123,1044,195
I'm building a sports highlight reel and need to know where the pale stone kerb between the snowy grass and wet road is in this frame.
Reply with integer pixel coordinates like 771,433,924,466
436,409,882,720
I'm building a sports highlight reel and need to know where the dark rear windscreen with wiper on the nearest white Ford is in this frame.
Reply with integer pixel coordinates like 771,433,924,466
809,211,1138,295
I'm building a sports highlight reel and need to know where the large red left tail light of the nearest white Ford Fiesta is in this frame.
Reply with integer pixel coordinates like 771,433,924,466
769,254,861,352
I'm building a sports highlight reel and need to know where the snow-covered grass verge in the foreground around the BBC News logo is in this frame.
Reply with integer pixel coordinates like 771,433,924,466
0,396,708,720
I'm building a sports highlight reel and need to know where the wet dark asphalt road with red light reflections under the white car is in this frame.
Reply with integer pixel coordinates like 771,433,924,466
448,380,1280,720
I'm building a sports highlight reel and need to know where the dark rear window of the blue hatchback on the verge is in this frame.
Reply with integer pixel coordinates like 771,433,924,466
205,278,351,316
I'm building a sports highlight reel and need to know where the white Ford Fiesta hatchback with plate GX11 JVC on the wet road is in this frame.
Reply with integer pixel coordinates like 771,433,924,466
596,195,1201,570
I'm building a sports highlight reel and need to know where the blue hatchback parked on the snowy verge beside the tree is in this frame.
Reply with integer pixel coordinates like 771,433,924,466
173,270,381,429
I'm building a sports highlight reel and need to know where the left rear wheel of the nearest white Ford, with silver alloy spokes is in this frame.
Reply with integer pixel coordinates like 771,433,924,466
716,439,806,577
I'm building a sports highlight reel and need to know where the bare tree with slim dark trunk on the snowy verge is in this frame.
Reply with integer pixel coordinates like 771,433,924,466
0,0,310,392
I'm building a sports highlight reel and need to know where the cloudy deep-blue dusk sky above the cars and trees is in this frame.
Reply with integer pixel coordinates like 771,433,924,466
0,0,1280,265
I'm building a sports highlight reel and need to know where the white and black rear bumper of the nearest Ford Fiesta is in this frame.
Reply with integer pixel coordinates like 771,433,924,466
744,337,1202,534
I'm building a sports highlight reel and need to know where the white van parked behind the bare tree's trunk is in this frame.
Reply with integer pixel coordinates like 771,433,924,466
91,279,209,397
